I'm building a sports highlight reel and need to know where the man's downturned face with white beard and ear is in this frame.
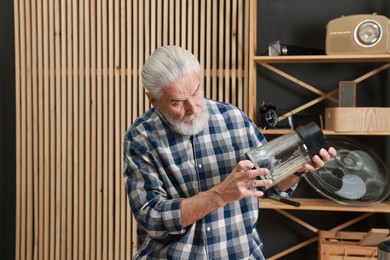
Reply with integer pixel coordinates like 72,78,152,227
148,68,209,135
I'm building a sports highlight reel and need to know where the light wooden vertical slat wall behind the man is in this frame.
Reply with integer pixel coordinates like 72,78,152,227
14,0,254,260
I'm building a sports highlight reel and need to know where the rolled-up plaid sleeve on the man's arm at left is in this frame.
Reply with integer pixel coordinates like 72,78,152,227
124,140,185,239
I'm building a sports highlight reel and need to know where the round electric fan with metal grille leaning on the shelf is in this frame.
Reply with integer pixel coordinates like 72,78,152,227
304,139,390,206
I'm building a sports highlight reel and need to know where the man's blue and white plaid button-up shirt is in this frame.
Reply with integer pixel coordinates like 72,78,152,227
124,99,274,259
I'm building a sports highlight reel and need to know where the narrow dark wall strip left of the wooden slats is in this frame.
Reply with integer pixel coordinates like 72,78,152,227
0,0,15,259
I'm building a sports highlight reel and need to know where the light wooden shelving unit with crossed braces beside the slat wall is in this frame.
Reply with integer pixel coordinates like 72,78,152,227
248,1,390,260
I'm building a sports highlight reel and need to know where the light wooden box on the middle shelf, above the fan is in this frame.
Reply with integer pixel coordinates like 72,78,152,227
325,107,390,132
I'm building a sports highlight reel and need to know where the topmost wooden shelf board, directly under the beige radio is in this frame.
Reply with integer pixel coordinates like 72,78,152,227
253,54,390,64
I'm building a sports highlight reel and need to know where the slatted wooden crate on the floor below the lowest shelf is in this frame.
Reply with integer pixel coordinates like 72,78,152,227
318,231,378,260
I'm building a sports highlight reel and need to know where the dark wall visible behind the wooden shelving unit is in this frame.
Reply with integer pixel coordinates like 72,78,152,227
257,0,390,260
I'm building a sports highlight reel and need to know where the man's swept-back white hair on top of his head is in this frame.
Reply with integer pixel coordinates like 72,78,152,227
141,46,201,100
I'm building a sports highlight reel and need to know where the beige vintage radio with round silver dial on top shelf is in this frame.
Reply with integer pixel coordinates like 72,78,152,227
326,14,390,54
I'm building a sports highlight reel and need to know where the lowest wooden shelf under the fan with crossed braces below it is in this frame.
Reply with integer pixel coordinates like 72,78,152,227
260,198,390,260
